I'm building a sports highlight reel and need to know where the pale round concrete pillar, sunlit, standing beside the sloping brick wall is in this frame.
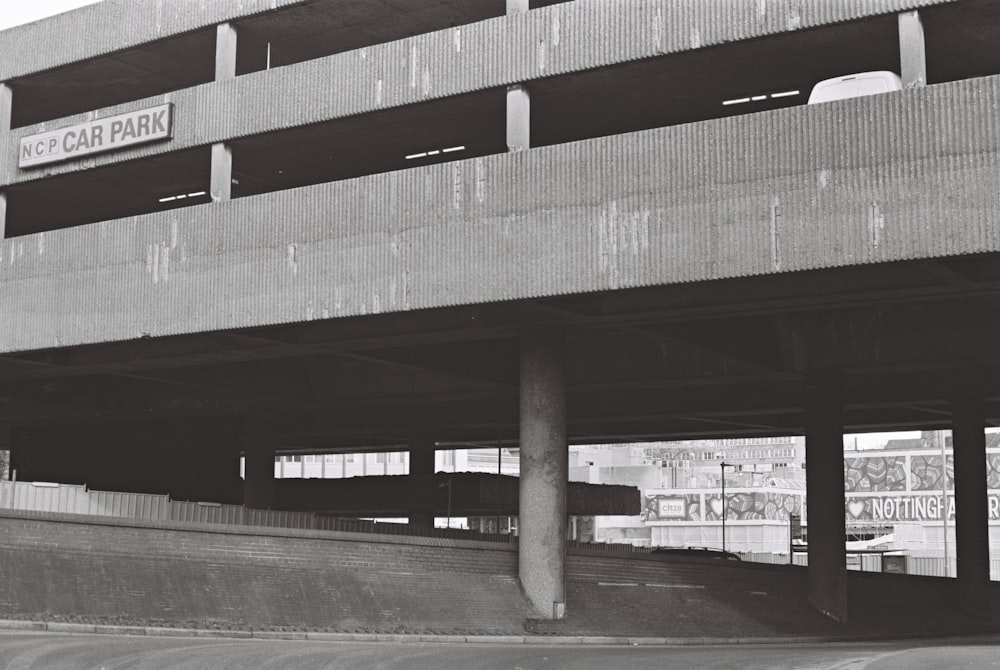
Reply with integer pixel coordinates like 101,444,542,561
518,329,569,619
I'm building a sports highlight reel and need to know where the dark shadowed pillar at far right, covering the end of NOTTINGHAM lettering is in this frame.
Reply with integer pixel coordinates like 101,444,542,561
951,394,990,615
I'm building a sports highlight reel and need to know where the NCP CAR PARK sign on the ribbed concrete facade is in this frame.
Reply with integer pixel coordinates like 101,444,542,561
17,103,174,168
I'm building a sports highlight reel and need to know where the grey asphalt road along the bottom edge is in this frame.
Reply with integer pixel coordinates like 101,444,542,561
0,632,1000,670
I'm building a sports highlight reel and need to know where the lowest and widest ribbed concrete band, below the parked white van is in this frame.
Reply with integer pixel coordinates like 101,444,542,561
0,77,1000,351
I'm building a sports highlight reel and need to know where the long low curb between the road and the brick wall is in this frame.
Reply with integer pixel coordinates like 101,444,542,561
0,619,998,647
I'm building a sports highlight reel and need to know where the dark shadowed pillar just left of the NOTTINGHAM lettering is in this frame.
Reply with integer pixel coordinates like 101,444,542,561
805,375,847,623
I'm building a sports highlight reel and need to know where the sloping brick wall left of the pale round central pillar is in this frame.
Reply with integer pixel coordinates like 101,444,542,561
0,511,529,632
